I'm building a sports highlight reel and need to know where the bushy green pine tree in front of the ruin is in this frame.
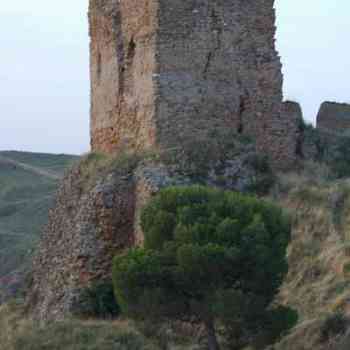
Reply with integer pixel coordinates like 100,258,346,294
113,186,296,349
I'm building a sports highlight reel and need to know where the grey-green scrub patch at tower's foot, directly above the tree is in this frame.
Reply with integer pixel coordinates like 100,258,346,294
159,129,275,194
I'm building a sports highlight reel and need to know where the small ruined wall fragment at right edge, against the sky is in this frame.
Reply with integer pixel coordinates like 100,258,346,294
317,102,350,133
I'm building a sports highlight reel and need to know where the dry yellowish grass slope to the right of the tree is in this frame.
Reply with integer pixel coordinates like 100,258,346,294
272,169,350,350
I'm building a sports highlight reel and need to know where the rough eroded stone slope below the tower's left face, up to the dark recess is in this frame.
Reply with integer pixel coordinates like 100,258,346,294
28,168,134,320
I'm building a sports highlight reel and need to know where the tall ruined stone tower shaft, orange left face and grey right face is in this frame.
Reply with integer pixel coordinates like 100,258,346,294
89,0,293,166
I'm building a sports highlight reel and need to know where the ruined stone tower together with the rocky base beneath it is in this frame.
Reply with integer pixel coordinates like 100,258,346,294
28,0,300,320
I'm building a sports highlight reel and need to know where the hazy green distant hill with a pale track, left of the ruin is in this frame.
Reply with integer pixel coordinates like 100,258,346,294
0,151,78,300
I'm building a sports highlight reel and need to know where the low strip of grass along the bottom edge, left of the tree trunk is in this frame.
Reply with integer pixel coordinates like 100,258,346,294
0,302,205,350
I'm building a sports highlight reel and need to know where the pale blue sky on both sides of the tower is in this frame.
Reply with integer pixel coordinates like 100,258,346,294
0,0,350,153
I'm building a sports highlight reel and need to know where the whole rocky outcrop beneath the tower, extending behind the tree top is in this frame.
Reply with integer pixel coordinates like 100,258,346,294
27,146,270,320
